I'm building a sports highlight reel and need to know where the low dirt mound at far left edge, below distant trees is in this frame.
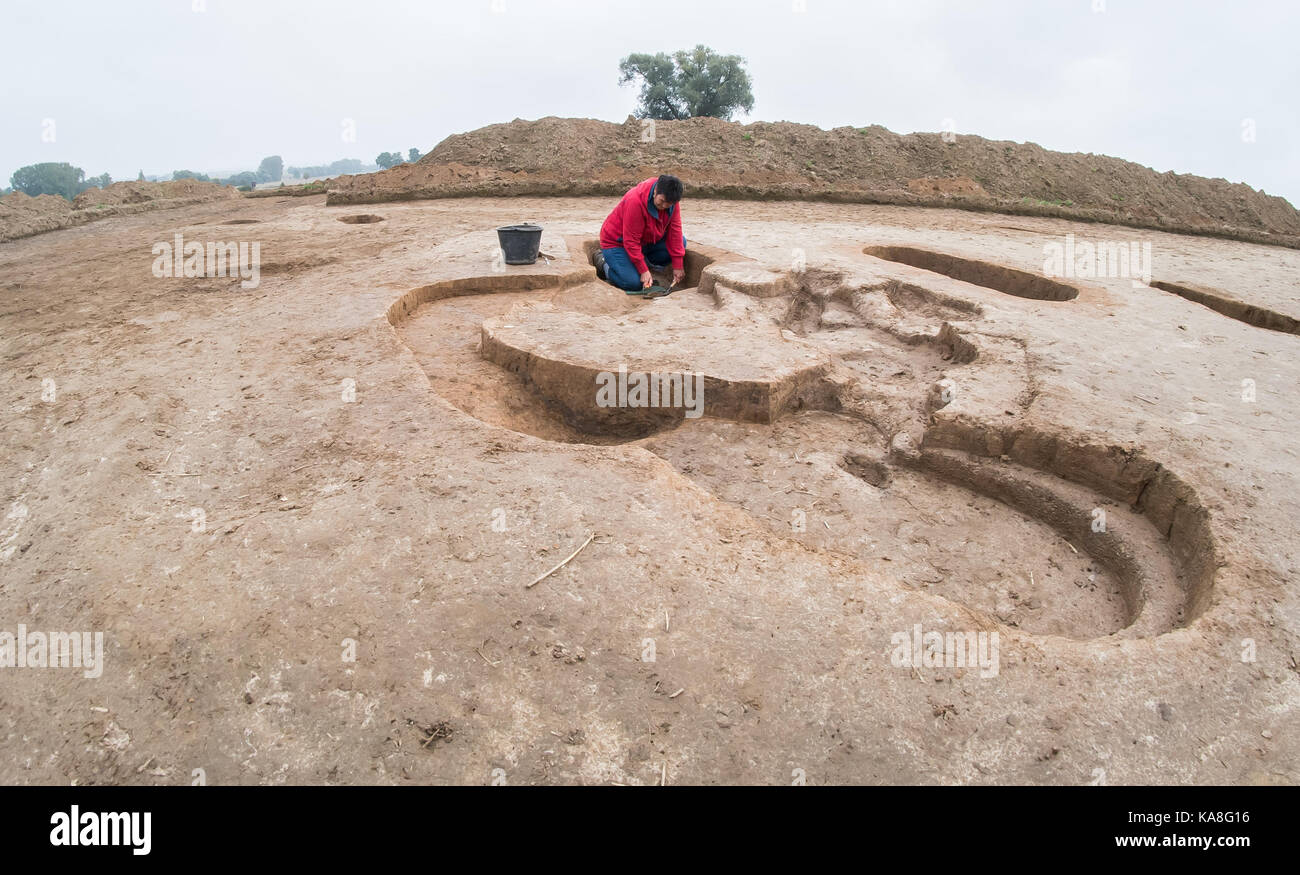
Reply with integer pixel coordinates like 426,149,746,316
0,179,239,243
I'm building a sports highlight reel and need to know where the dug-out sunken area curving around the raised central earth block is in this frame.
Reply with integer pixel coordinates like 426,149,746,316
389,242,1217,638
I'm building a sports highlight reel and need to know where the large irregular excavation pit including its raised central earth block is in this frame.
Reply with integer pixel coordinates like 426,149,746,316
390,230,1214,641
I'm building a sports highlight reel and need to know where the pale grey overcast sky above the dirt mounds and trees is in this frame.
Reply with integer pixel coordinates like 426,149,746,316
0,0,1300,204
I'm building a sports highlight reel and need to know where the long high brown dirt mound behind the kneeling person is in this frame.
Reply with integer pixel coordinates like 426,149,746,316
329,117,1300,247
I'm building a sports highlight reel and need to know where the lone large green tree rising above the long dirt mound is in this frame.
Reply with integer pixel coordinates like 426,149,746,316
619,46,754,120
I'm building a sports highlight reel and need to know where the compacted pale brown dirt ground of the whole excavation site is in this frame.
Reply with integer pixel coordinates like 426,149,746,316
0,196,1300,784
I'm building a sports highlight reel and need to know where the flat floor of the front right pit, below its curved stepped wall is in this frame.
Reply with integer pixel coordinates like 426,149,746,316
644,412,1128,638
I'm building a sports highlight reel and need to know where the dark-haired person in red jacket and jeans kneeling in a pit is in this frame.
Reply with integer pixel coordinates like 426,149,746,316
595,174,686,294
